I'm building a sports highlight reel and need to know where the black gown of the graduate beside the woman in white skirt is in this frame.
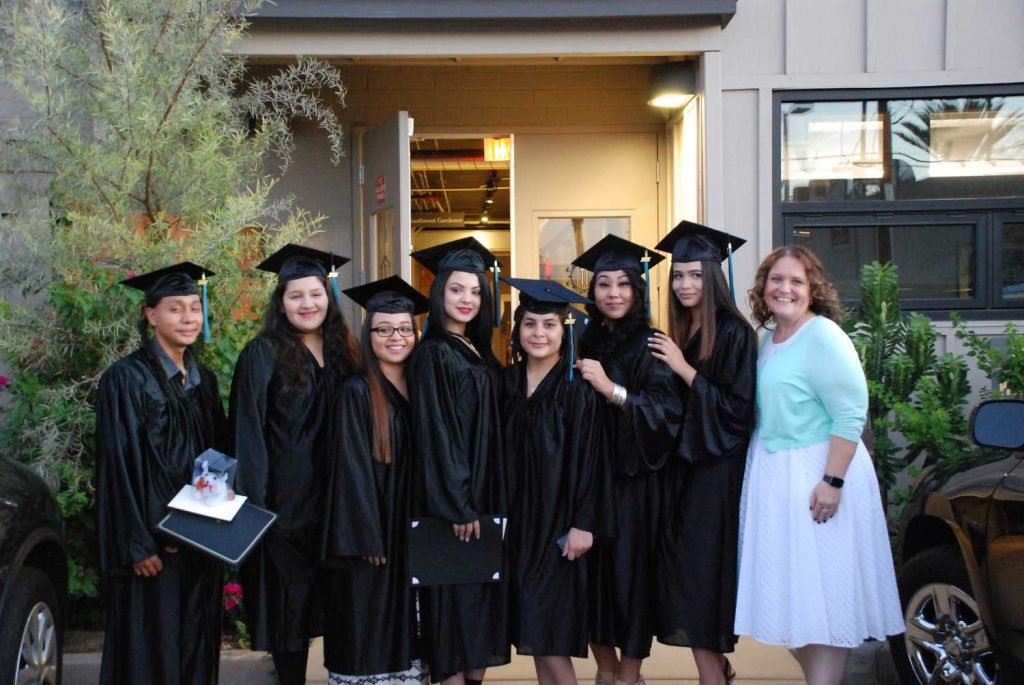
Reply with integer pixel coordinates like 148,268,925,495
657,313,758,652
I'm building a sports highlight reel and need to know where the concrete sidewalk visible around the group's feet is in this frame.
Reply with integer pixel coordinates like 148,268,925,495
63,638,898,685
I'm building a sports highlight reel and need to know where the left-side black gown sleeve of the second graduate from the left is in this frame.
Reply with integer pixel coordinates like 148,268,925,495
230,337,274,501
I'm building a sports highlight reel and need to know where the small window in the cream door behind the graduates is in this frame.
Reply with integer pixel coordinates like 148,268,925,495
539,216,630,294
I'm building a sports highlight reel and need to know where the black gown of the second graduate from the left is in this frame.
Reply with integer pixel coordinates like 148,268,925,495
230,335,333,651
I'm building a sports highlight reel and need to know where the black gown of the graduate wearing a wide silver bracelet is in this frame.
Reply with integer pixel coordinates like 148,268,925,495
591,327,682,658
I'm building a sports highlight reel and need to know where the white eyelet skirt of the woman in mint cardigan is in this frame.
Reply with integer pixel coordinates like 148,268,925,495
735,433,903,647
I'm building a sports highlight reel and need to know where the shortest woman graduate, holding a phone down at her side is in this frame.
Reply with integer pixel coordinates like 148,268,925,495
502,279,614,685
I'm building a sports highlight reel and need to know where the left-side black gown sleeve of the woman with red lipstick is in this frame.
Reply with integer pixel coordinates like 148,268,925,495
413,343,479,523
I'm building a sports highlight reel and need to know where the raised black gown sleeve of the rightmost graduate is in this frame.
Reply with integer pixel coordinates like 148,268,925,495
679,316,757,464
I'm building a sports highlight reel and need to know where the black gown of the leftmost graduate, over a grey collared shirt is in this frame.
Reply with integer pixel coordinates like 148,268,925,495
96,350,224,685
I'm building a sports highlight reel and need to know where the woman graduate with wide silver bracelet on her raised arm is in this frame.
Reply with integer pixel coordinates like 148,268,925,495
572,236,682,685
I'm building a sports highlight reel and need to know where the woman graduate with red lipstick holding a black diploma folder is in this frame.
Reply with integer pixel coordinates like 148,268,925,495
409,238,510,685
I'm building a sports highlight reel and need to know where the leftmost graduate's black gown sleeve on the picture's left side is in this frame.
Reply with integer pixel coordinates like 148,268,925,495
96,363,156,573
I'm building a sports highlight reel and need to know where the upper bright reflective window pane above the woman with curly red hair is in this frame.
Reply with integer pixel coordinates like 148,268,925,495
779,95,1024,202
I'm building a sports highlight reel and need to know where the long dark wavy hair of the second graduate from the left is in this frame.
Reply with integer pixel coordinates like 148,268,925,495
262,275,359,392
